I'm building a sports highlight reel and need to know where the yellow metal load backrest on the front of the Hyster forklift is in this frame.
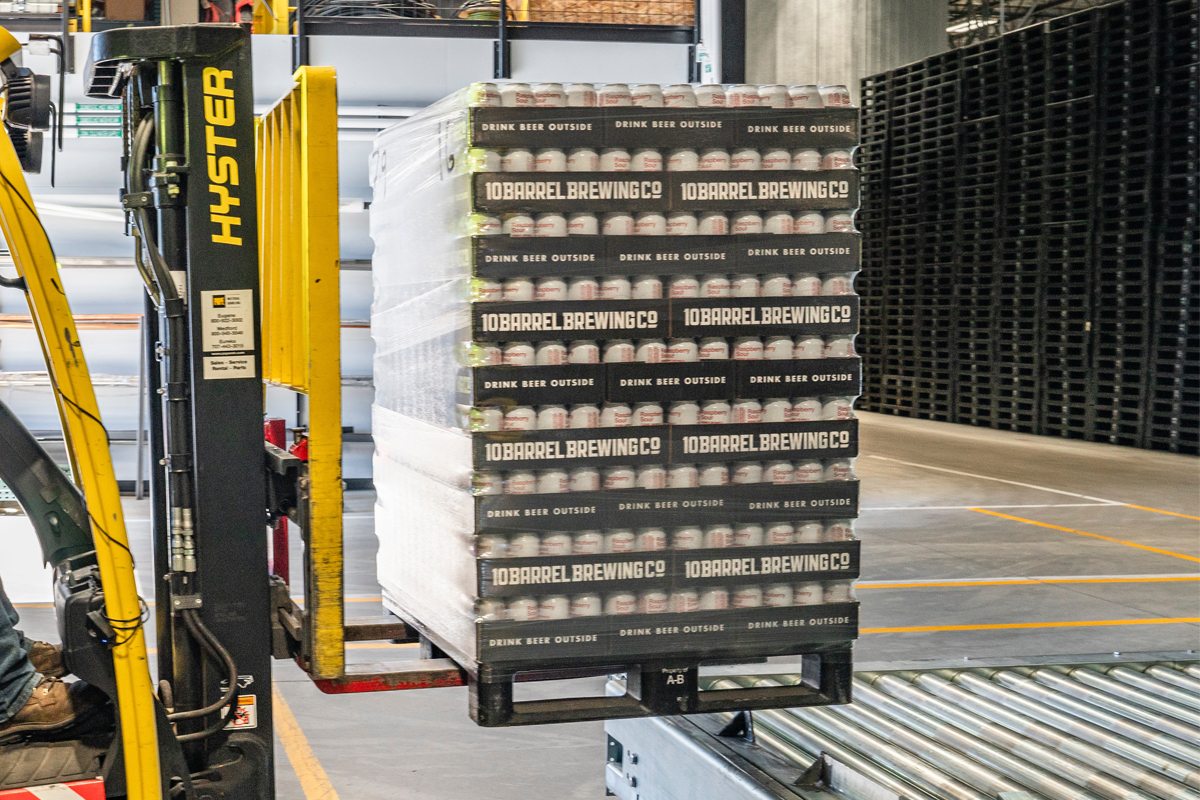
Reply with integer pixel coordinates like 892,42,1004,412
258,67,346,678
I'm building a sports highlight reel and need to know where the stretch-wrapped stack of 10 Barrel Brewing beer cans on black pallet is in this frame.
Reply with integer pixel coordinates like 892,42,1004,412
371,83,860,672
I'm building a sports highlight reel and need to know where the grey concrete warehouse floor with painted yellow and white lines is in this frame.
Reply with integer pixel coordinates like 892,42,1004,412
4,415,1200,800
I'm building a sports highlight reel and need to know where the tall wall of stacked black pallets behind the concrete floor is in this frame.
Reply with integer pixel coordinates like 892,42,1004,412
859,0,1200,453
